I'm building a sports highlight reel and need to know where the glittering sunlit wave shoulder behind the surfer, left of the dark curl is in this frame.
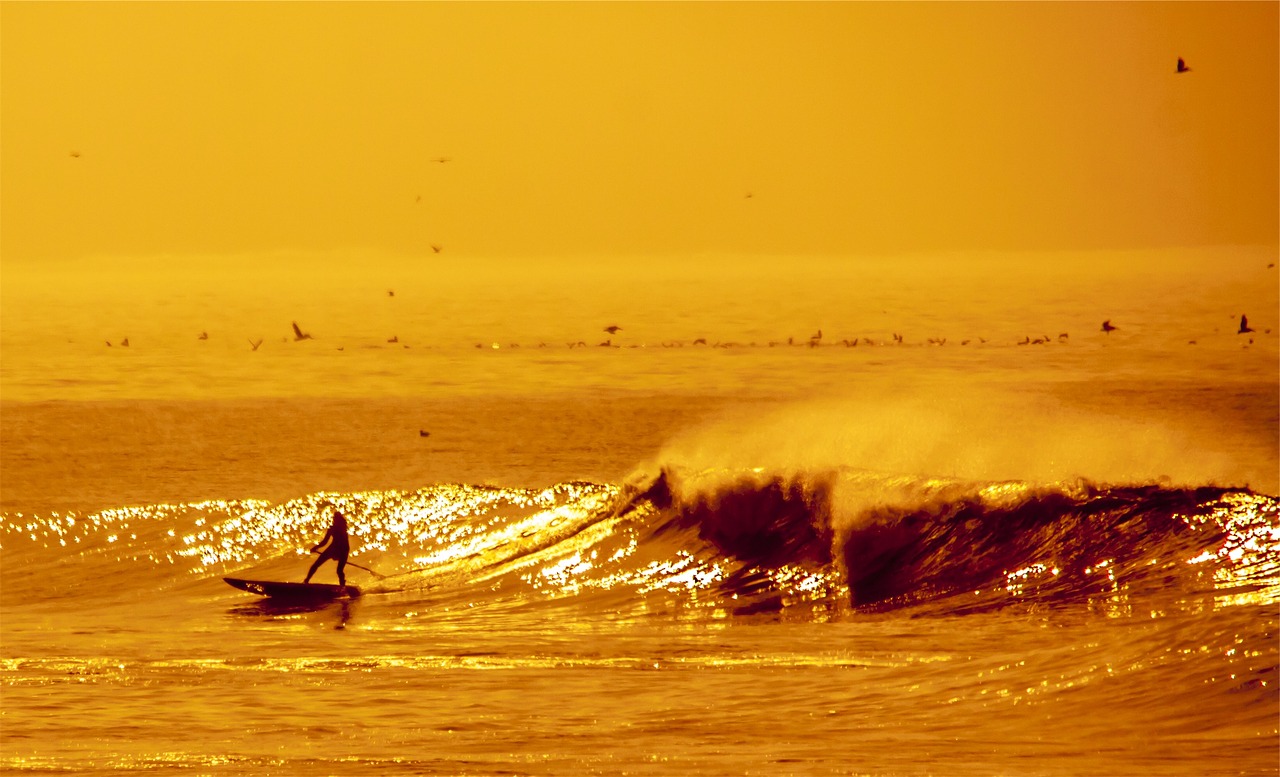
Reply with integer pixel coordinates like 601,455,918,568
0,483,617,593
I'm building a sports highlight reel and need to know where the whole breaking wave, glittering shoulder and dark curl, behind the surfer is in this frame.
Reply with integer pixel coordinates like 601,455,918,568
0,469,1280,617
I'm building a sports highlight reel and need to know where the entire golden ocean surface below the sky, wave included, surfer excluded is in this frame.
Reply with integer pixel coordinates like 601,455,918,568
0,248,1280,776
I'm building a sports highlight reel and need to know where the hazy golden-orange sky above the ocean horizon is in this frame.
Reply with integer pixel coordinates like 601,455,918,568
0,3,1280,262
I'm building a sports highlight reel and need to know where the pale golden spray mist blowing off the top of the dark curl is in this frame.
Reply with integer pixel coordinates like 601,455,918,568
659,389,1262,485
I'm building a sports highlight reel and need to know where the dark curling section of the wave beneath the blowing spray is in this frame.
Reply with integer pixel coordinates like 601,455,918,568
634,470,1280,609
